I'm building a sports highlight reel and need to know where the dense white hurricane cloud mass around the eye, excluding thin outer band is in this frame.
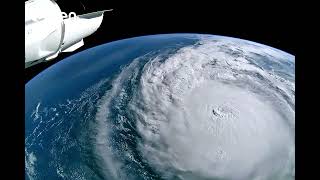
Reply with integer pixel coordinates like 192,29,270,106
131,37,294,179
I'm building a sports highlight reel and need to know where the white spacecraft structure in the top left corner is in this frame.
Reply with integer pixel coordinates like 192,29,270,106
25,0,112,68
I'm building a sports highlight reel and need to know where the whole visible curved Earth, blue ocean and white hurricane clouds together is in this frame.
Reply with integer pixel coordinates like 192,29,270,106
25,34,295,180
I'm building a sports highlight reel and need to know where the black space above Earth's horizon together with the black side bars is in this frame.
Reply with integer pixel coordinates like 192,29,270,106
4,0,319,179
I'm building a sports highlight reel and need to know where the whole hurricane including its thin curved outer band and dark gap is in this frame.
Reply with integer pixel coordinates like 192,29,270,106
92,37,295,180
